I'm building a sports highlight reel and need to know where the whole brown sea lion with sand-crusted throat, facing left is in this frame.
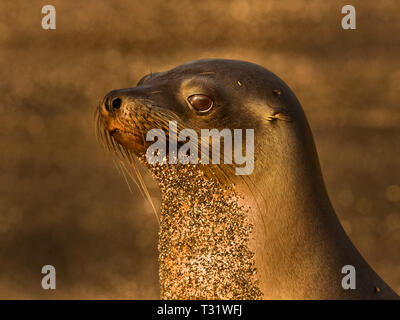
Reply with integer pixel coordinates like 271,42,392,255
98,59,398,299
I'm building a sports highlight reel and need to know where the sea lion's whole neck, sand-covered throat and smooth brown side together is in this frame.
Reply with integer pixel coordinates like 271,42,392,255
152,125,396,299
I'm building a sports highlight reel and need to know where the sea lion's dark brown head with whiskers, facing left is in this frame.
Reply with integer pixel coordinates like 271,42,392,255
99,59,314,182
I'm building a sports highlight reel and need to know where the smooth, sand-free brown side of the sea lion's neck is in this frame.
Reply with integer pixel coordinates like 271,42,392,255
234,127,393,299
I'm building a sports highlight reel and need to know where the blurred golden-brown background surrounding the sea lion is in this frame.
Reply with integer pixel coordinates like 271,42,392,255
0,0,400,299
